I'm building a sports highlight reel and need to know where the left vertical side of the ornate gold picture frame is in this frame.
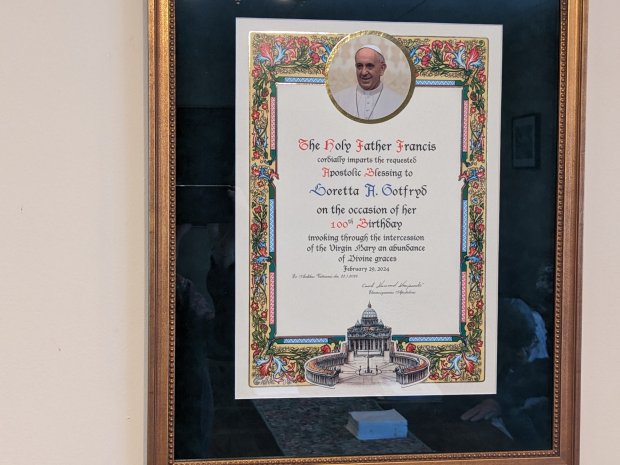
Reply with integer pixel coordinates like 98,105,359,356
147,0,176,465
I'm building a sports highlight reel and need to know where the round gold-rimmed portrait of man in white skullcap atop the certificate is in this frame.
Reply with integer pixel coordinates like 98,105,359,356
326,31,416,123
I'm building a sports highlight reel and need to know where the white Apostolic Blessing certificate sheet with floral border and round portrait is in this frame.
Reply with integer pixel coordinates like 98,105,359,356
235,18,502,398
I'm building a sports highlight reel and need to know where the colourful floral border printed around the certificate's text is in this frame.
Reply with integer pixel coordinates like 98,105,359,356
249,33,488,387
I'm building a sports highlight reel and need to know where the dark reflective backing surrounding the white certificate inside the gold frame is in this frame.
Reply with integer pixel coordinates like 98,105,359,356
175,0,559,459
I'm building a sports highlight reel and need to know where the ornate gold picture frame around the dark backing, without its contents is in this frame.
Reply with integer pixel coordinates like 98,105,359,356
147,0,587,465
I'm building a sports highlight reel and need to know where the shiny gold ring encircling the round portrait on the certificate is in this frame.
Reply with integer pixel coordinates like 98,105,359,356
325,30,418,124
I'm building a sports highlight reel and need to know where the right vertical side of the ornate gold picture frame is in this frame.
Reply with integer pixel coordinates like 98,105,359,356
554,0,588,465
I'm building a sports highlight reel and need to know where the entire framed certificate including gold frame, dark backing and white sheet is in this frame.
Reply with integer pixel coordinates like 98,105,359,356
149,0,585,464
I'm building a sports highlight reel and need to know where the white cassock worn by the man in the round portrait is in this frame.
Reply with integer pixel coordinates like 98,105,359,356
334,83,404,120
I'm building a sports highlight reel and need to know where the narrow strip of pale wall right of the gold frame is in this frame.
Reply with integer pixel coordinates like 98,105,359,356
581,0,620,465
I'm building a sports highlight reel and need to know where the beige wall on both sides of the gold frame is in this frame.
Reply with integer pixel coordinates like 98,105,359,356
0,0,620,465
